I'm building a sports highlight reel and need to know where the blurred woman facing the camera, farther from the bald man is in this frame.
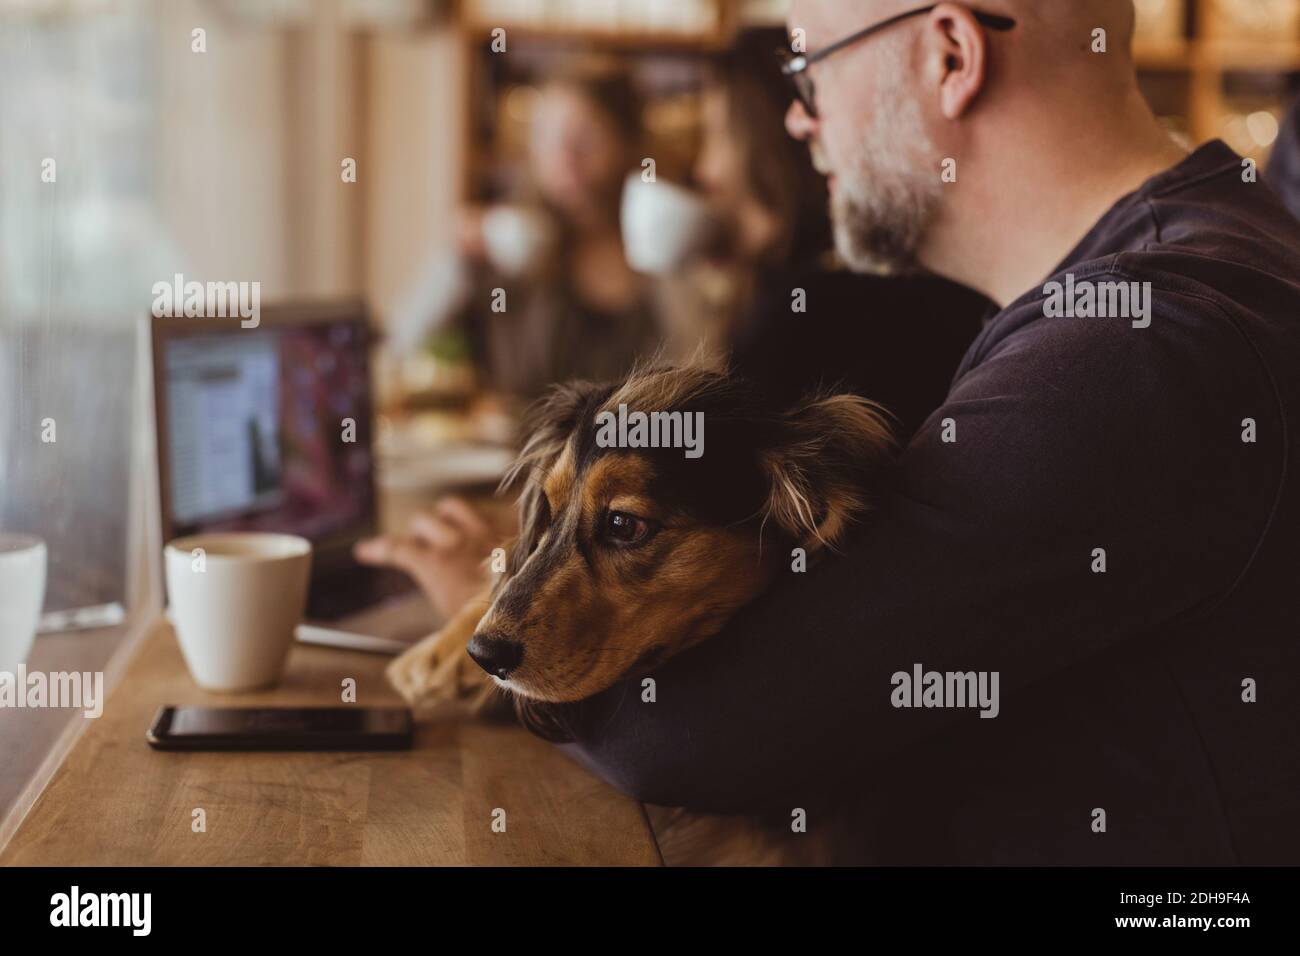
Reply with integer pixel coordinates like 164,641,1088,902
393,60,657,398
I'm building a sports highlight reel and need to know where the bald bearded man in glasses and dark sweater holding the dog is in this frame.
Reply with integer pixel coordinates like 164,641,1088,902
556,0,1300,864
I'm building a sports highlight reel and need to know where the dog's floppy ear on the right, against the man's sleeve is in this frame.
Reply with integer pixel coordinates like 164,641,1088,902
762,395,894,553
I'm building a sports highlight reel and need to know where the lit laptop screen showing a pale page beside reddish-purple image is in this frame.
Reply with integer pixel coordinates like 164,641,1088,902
159,317,374,554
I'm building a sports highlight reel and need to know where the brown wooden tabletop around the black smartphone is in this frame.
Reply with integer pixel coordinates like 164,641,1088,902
0,613,660,866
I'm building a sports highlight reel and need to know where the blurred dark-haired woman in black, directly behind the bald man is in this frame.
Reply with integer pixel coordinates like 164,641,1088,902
696,29,991,441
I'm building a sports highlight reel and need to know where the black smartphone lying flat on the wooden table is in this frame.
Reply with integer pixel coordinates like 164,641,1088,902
146,708,412,750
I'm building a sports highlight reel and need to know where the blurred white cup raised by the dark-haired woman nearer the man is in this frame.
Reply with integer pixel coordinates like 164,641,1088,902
620,173,718,276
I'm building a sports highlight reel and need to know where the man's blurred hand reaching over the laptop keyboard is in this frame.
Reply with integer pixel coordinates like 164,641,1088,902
354,498,501,617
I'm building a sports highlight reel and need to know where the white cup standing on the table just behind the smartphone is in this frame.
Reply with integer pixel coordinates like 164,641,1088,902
164,532,312,691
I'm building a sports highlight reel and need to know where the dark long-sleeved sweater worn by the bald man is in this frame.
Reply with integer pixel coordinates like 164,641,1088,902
559,143,1300,864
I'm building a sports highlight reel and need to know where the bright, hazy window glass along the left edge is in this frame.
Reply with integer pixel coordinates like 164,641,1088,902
0,0,160,621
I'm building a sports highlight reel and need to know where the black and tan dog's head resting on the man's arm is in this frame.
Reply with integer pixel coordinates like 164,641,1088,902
469,367,892,702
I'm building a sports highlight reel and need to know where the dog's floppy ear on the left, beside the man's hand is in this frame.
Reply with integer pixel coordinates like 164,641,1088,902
497,381,611,580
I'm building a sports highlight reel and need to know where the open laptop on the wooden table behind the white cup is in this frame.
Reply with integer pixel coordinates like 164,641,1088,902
152,300,432,653
